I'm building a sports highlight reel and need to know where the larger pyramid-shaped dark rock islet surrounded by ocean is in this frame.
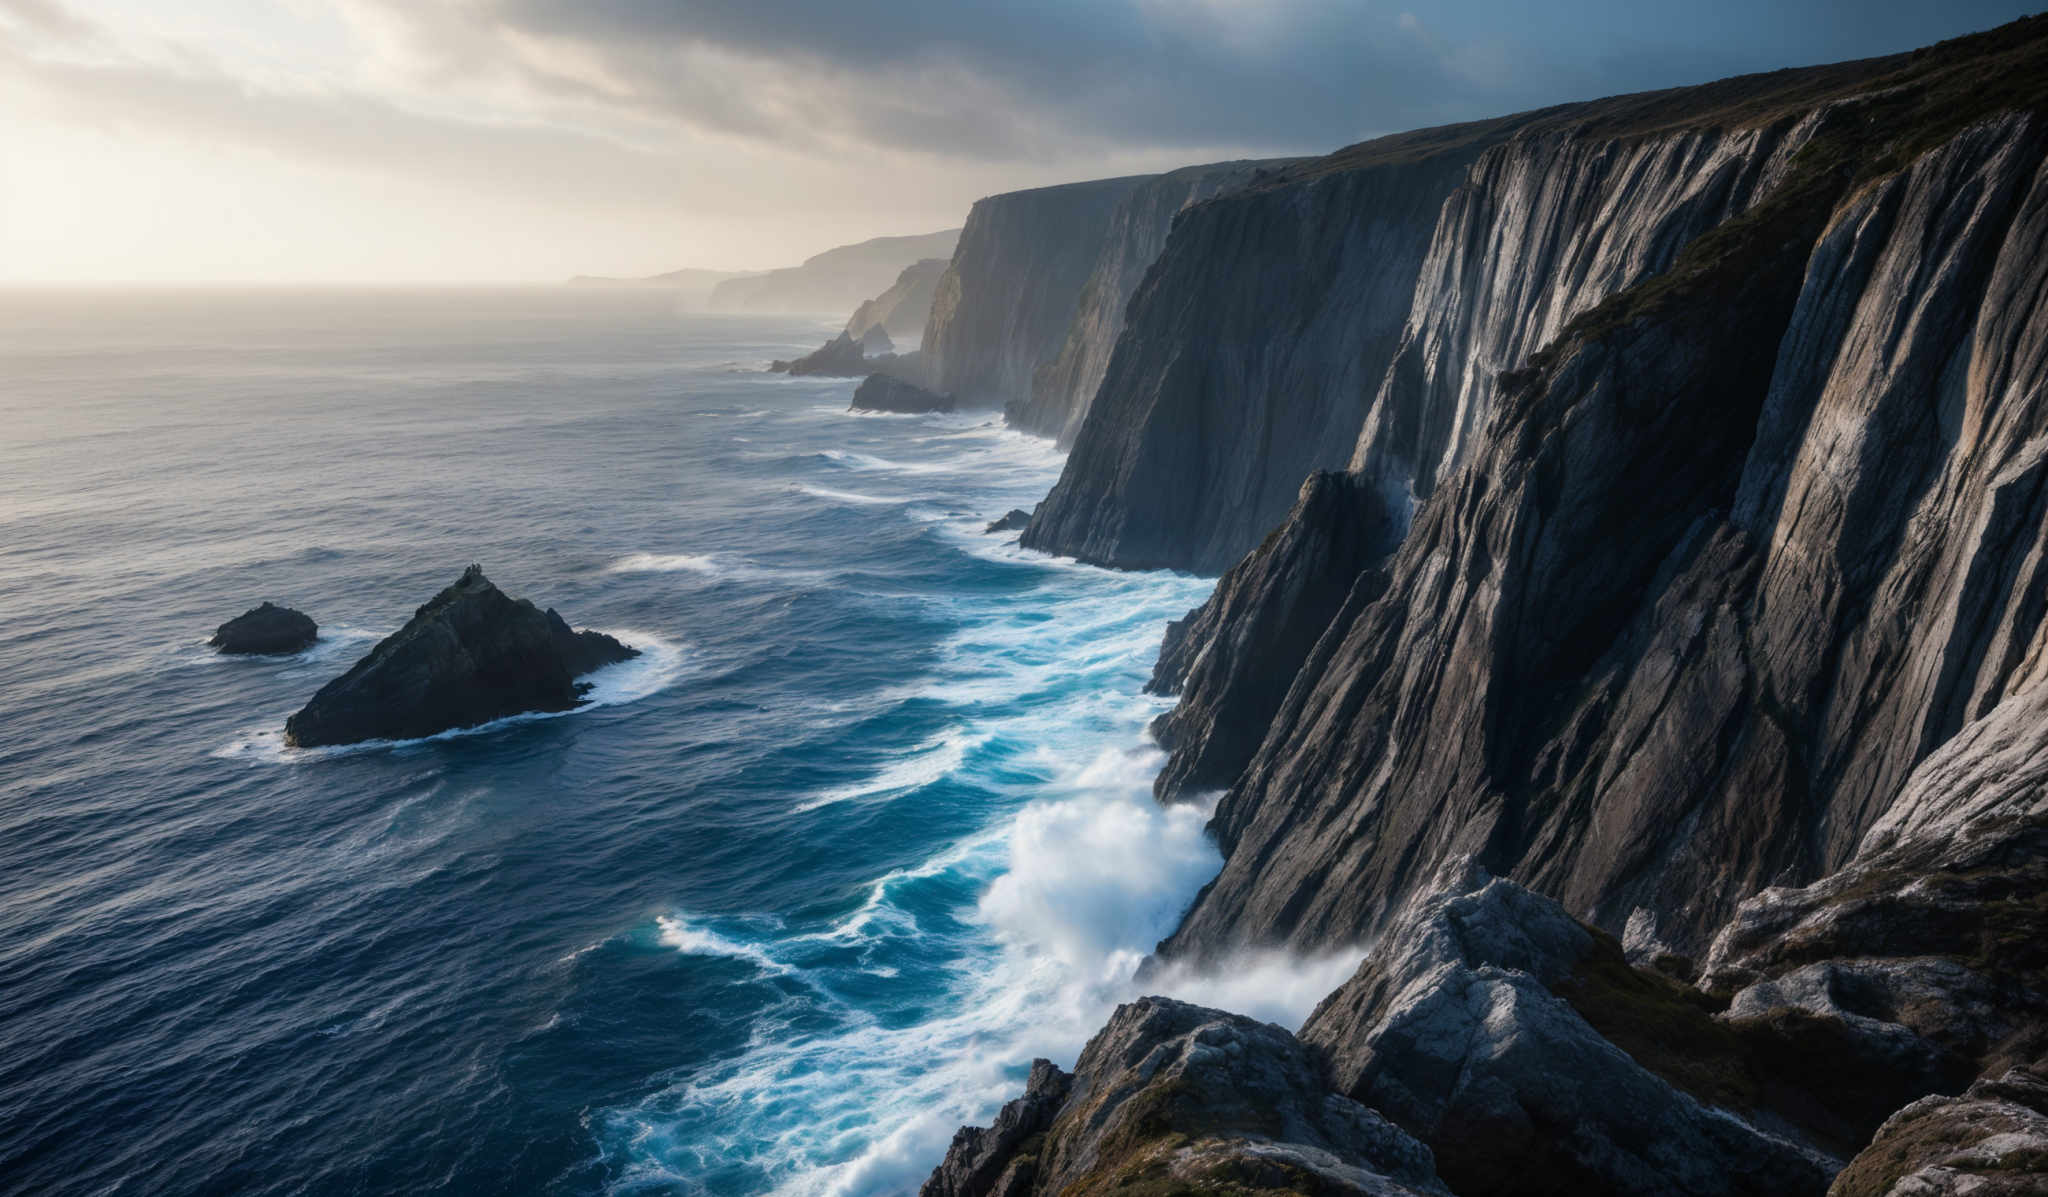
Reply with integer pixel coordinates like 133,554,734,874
285,566,639,748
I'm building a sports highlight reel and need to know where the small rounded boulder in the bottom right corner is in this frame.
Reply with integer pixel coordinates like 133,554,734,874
1829,1058,2048,1197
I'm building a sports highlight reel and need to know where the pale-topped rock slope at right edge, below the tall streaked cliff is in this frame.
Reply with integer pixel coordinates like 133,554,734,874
1700,683,2048,1097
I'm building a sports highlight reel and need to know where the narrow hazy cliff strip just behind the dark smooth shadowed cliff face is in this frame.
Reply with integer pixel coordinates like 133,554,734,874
1004,158,1288,447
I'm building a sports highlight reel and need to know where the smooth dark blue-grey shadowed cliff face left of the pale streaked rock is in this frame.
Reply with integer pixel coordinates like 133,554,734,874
1024,131,1489,572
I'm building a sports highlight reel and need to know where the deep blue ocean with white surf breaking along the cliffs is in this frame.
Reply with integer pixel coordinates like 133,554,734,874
0,289,1356,1195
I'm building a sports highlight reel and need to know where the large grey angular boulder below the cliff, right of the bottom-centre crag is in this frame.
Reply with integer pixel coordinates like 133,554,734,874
1300,859,1839,1197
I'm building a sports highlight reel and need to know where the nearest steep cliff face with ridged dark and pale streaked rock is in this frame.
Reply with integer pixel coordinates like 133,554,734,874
1155,63,2048,953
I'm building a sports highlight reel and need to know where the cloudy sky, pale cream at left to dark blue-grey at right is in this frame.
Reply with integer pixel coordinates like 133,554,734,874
0,0,2044,283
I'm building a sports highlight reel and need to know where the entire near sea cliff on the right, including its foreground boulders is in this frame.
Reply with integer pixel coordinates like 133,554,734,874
928,18,2048,1197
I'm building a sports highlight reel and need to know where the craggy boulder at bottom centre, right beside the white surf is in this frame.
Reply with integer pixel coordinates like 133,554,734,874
922,998,1448,1197
